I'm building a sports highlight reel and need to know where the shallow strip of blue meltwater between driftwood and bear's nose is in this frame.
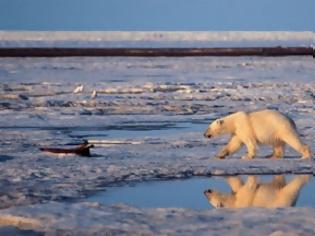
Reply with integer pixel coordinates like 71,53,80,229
0,122,207,145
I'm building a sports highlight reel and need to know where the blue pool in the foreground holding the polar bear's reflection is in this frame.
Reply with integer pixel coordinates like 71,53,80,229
88,175,315,210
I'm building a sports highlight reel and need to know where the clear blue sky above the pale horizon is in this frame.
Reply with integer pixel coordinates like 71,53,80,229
0,0,315,31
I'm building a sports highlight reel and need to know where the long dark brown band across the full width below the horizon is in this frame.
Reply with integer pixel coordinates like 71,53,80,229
0,47,315,57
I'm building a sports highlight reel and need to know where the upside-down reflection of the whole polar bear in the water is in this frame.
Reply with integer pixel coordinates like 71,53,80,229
204,175,310,208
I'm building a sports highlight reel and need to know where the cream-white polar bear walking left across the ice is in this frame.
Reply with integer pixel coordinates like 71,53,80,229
204,109,311,159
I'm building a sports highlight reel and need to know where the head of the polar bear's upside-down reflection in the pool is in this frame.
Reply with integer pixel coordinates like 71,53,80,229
204,189,235,208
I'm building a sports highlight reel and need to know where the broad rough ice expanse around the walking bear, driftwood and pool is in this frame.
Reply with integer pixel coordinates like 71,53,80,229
0,57,315,235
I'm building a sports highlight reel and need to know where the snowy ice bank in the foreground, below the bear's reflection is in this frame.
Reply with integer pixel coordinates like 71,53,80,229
0,202,315,235
